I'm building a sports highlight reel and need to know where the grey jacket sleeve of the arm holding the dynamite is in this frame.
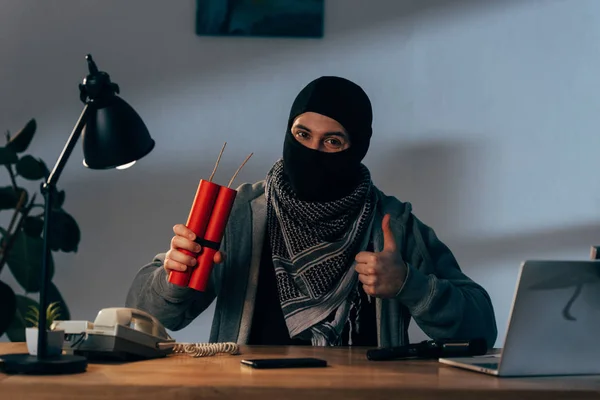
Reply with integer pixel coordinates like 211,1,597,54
125,253,216,331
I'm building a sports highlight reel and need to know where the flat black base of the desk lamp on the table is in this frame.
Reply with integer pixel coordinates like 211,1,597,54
0,354,88,375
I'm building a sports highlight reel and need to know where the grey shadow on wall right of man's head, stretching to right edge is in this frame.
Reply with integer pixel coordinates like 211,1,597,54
365,135,600,270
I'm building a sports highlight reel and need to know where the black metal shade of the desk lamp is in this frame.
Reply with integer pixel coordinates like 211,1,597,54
82,95,155,169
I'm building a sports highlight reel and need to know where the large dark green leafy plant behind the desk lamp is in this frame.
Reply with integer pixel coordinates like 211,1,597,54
0,119,80,342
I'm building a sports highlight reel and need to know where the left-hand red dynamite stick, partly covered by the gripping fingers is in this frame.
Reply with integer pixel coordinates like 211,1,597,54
169,179,221,287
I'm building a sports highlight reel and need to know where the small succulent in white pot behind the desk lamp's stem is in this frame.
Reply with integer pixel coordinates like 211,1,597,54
25,302,65,356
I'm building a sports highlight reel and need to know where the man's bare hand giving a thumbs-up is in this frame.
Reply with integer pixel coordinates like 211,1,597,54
355,214,407,298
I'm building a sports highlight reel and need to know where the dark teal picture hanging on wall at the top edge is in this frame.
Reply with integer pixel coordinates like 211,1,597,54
196,0,325,38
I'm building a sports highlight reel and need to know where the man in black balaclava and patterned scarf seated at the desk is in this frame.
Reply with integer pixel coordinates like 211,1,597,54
126,76,497,347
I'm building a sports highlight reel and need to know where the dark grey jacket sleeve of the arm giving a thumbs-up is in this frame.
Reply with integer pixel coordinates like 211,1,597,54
397,215,498,348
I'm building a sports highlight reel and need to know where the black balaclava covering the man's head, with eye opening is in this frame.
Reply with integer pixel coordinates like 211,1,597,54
283,76,373,202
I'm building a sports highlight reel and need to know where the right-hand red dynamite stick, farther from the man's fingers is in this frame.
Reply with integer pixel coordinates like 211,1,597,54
188,186,237,292
